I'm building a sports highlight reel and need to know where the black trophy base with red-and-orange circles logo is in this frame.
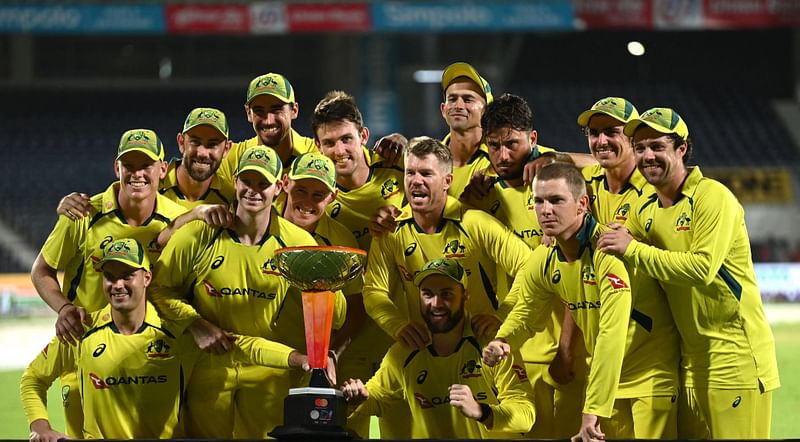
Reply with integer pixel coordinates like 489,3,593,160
269,387,358,440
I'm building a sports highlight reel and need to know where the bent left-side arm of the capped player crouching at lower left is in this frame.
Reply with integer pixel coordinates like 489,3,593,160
19,338,76,440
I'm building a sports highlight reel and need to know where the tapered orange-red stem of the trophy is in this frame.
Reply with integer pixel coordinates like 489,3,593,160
303,290,336,376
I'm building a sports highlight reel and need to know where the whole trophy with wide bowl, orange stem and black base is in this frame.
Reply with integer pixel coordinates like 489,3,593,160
269,246,367,439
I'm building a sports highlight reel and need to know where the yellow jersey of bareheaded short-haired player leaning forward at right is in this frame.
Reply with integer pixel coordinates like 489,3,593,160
497,214,631,417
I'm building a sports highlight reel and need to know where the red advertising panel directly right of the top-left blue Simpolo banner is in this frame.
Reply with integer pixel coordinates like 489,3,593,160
165,4,250,34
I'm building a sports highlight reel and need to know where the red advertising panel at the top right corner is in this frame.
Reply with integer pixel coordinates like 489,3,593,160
704,0,800,28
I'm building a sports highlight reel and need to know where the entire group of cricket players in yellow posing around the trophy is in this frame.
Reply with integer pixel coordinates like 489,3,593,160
21,62,780,442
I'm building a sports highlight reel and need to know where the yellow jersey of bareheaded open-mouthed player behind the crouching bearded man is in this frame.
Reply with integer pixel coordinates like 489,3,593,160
364,197,531,337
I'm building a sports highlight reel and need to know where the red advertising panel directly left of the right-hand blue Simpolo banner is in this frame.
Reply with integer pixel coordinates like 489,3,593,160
287,3,372,32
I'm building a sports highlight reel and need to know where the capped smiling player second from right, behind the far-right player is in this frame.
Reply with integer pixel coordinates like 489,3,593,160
578,97,680,439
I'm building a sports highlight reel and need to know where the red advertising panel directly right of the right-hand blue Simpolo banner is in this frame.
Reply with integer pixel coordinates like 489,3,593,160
573,0,653,29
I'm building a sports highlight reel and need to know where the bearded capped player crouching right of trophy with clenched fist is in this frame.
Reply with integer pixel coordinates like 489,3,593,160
342,258,535,439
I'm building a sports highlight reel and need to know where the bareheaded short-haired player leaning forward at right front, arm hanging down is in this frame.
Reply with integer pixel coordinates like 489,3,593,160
483,163,631,442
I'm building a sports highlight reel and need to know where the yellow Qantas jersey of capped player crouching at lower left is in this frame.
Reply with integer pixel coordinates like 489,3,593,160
20,303,292,439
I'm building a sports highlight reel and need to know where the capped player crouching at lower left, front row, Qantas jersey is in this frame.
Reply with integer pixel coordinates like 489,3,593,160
20,238,308,441
